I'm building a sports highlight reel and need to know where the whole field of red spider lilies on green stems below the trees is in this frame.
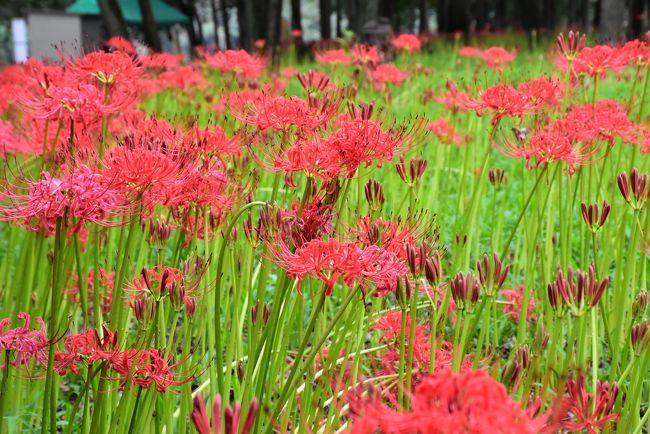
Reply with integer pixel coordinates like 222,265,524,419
0,32,650,434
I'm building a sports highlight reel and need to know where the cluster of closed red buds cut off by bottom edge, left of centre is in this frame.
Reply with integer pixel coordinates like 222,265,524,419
192,393,260,434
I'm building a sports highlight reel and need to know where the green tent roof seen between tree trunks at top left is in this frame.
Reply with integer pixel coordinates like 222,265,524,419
66,0,189,26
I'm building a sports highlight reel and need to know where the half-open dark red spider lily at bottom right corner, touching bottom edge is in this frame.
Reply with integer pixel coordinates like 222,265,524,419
560,376,619,434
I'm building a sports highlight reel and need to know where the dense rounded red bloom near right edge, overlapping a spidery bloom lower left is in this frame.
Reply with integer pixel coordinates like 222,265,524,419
556,99,636,145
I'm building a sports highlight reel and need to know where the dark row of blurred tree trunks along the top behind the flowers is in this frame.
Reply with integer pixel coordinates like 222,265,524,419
0,0,650,60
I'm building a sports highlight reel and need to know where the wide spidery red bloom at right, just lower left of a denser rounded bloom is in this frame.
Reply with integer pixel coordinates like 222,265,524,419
497,124,599,174
